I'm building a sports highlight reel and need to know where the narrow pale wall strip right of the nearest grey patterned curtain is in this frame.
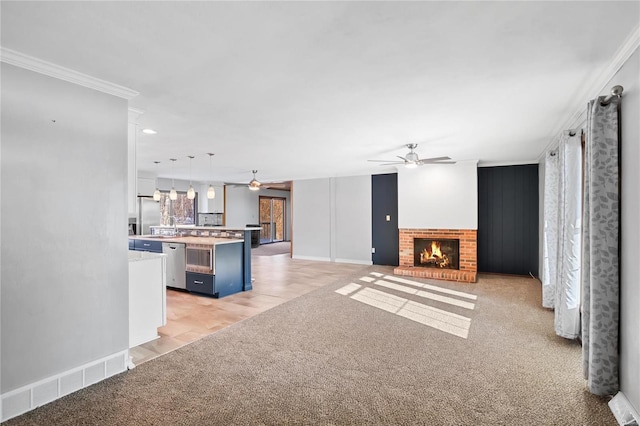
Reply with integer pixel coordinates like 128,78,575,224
616,45,640,413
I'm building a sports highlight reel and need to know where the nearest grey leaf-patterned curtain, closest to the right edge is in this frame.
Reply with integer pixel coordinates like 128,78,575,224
582,96,620,395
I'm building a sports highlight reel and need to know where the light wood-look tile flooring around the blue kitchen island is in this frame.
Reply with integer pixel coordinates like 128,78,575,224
129,254,367,365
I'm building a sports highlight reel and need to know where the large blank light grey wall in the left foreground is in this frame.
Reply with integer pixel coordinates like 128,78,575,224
0,63,129,393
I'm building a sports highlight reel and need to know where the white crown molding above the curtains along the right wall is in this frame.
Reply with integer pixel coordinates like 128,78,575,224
538,25,640,161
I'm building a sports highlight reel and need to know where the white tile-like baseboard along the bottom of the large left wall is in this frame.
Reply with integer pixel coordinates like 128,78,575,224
0,349,129,422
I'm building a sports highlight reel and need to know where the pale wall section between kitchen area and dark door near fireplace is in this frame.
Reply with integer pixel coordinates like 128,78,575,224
293,176,371,265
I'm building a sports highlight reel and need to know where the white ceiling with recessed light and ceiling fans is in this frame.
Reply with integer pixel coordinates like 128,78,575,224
0,0,640,182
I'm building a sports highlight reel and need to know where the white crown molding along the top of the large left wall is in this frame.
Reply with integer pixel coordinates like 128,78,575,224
0,46,139,100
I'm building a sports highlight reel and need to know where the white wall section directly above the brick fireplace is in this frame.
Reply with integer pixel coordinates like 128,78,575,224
398,161,478,229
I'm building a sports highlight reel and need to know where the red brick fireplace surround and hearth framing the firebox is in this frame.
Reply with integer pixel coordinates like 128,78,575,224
393,229,478,283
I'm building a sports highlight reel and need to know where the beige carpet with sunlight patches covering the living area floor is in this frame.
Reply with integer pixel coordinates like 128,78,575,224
6,264,616,426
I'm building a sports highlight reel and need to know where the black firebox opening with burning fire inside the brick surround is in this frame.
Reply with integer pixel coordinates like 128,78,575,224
413,238,460,269
